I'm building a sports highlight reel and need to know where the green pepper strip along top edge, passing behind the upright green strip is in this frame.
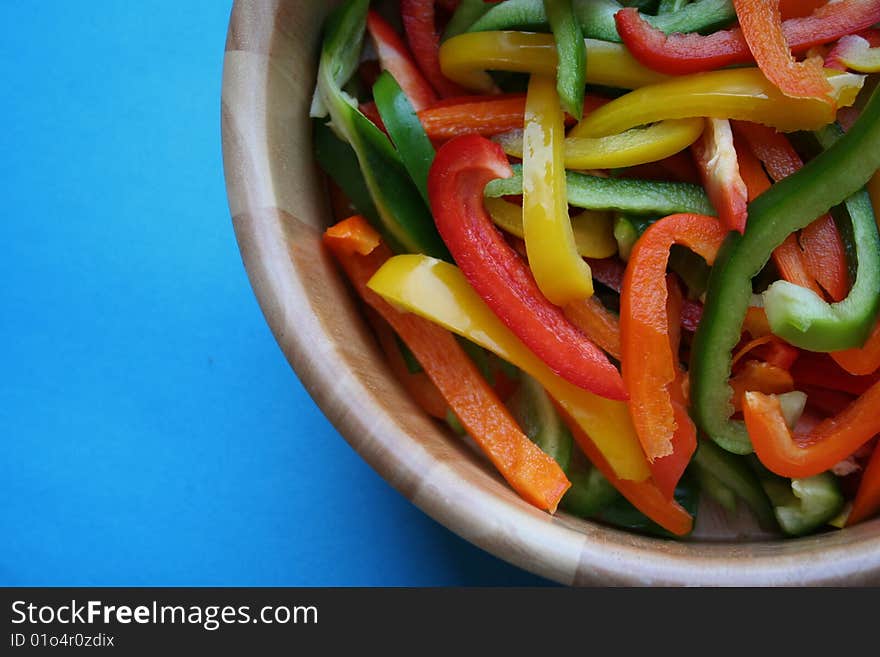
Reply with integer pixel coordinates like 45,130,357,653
468,0,736,42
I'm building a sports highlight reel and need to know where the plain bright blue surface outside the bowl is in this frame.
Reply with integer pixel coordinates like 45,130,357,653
0,0,545,586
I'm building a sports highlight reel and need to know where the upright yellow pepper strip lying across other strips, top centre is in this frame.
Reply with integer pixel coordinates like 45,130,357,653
523,75,593,306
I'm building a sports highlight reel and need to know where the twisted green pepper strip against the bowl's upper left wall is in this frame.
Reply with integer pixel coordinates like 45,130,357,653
313,0,451,260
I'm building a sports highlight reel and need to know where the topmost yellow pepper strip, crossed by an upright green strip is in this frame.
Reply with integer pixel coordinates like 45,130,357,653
440,32,669,93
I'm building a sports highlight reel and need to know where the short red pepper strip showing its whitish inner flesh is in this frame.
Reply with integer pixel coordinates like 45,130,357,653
691,119,749,233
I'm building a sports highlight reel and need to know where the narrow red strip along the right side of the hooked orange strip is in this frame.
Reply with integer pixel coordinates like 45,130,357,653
651,274,697,499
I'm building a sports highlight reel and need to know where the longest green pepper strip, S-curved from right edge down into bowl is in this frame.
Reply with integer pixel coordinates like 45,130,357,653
690,83,880,454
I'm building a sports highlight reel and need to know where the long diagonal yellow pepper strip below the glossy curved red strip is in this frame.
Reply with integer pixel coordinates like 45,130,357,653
367,254,650,481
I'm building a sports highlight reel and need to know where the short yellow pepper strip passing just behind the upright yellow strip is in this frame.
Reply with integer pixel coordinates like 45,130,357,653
494,117,706,169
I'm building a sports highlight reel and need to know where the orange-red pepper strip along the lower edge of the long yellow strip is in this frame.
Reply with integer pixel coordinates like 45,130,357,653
556,405,694,536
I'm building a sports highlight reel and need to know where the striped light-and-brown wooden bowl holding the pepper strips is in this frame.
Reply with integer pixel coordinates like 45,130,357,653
222,0,880,586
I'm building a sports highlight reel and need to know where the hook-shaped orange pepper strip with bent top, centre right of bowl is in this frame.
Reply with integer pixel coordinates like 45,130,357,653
620,214,727,464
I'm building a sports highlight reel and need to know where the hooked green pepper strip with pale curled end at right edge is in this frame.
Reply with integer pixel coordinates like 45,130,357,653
763,126,880,352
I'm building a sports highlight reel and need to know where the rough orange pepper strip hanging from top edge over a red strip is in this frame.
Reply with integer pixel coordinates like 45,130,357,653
733,0,833,103
